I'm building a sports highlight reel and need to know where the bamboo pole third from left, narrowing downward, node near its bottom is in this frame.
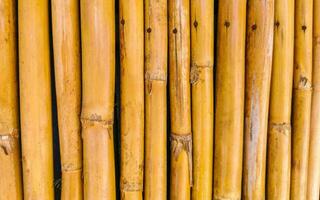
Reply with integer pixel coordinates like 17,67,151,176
51,0,82,200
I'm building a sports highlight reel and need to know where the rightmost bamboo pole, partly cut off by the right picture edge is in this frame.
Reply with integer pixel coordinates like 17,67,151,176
307,0,320,200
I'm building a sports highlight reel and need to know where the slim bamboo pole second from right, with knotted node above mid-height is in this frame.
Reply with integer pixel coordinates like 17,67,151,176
290,0,313,200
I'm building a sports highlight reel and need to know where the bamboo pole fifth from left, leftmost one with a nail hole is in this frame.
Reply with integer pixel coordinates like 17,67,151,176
119,0,144,199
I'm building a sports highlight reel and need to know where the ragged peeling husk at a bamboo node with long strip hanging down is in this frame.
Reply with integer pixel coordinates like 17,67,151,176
170,132,193,187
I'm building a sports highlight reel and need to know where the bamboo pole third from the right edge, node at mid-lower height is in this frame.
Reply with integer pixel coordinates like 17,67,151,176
267,0,294,200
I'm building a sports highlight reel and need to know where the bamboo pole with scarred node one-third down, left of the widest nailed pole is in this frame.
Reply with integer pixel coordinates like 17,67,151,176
190,0,214,199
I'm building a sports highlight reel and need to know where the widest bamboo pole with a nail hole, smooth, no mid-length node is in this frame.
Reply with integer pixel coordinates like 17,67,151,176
214,0,246,199
